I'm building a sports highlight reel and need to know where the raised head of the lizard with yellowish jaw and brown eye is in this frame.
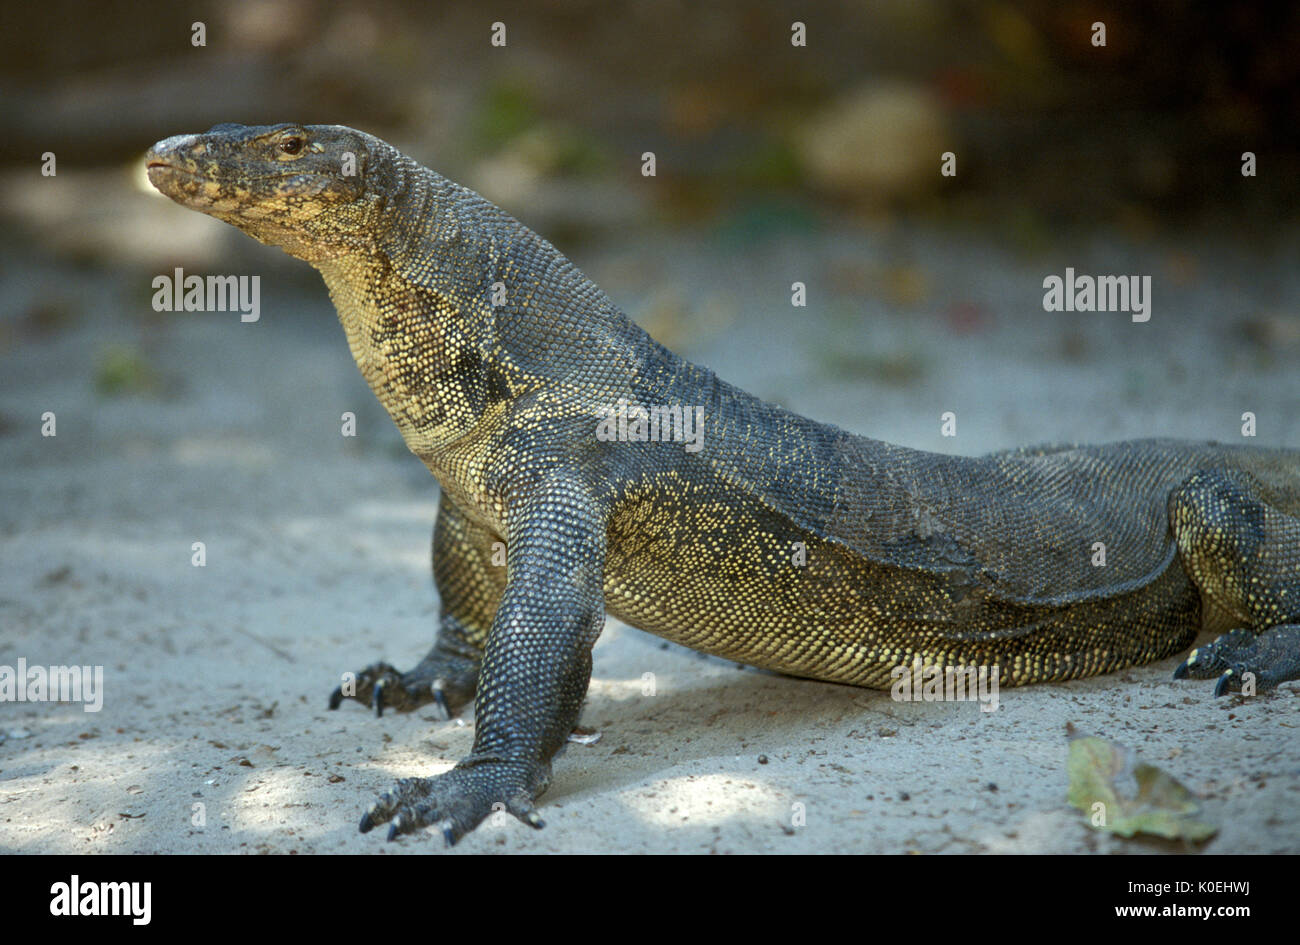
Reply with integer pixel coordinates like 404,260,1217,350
144,125,384,261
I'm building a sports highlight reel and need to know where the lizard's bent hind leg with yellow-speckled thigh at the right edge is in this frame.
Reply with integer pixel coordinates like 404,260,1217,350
1169,469,1300,695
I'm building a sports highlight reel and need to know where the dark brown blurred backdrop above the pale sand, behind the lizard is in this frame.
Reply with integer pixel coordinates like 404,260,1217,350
0,0,1300,222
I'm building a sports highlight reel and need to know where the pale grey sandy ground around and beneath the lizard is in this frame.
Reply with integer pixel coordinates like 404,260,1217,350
0,222,1300,854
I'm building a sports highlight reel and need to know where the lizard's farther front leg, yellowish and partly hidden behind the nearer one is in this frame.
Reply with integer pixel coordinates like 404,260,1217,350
329,493,506,719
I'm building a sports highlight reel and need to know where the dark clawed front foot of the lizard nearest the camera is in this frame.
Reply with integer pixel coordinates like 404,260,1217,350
361,758,546,846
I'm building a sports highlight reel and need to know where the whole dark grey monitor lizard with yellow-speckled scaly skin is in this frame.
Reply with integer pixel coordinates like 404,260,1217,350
147,125,1300,842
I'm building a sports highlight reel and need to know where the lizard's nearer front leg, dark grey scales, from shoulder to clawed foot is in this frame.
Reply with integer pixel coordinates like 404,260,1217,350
361,473,606,845
